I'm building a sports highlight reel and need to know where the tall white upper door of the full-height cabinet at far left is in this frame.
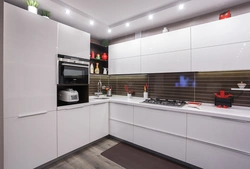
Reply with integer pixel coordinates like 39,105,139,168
3,3,57,118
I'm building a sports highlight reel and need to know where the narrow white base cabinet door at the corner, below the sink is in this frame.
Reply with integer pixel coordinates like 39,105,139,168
90,103,109,142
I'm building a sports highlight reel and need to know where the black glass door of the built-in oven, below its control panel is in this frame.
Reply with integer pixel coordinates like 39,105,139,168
59,63,89,84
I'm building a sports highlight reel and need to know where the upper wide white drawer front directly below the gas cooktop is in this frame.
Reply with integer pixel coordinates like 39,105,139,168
134,107,186,137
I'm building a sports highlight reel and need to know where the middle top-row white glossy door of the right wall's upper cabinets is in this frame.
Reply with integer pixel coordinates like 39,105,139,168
141,27,190,55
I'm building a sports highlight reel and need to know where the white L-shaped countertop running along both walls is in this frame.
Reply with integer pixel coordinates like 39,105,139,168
57,95,250,122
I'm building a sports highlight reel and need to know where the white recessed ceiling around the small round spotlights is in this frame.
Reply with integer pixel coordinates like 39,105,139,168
5,0,250,39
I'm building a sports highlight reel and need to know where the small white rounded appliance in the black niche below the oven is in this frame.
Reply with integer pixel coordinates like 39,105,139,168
58,88,79,103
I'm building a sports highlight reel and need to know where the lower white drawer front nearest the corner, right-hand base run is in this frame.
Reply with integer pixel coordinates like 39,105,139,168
109,120,134,143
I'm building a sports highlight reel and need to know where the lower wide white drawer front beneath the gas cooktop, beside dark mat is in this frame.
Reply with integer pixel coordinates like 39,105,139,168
134,127,186,161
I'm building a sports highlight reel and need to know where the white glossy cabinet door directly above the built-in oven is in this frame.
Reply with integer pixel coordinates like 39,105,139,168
58,23,90,59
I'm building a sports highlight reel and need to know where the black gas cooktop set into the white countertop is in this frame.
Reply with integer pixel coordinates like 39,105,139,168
143,98,186,107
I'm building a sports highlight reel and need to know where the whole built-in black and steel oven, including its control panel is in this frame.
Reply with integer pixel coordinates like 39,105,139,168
58,55,89,84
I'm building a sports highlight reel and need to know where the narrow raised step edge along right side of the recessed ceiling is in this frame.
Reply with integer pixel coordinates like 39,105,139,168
109,0,191,28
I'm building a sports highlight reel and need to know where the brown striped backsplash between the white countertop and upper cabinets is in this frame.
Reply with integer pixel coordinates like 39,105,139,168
89,71,250,107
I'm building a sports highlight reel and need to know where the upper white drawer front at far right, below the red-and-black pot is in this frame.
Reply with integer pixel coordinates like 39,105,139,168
187,114,250,153
